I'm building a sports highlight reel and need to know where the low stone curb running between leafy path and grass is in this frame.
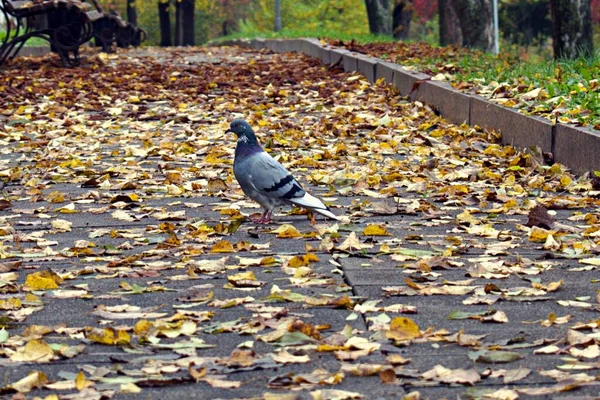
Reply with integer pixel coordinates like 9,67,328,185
218,39,600,174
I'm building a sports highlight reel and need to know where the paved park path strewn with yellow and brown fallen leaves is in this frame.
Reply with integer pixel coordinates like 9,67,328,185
0,47,600,400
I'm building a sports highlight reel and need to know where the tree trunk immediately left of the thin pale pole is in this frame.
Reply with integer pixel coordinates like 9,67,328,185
451,0,492,51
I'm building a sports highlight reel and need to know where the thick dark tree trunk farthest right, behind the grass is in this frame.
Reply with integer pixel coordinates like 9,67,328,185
550,0,594,58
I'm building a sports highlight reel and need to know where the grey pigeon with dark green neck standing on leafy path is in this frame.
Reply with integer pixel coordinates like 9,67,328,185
226,119,339,224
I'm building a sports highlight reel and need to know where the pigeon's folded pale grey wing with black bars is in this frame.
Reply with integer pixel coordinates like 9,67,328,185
251,151,306,201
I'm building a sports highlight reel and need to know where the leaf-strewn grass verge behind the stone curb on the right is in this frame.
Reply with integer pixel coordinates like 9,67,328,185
326,40,600,129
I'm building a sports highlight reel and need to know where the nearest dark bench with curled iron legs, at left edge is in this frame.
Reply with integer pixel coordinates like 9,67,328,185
0,0,102,66
